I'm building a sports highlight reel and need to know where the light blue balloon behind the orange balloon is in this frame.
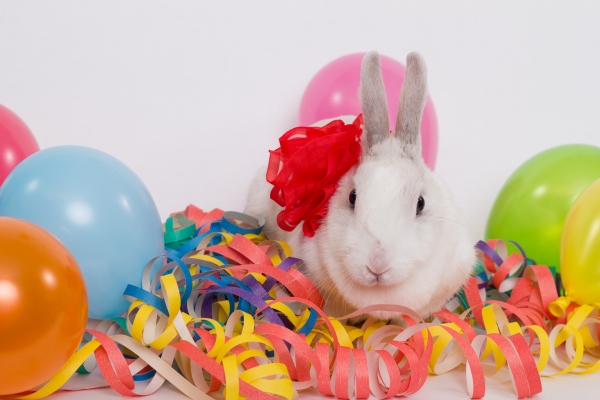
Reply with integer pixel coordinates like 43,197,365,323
0,146,164,319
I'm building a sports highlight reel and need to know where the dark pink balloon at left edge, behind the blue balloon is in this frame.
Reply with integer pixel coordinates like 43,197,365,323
0,104,40,185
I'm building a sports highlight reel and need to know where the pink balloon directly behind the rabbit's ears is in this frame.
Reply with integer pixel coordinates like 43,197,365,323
299,53,438,170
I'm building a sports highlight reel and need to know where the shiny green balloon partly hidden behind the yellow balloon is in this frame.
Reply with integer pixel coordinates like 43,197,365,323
485,144,600,271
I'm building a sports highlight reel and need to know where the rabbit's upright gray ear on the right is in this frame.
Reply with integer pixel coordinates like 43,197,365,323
394,52,427,159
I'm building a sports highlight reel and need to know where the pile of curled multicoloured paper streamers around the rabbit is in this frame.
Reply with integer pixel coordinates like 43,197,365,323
8,211,600,400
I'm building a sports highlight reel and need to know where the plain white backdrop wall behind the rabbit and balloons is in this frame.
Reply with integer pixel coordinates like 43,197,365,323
0,0,600,241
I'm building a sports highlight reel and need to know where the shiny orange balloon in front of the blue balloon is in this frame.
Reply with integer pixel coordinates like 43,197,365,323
0,217,88,396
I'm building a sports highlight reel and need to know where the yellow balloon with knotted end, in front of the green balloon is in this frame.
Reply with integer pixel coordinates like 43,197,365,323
551,179,600,316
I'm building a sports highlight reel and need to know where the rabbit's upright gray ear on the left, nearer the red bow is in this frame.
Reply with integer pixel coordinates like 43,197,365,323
359,51,390,147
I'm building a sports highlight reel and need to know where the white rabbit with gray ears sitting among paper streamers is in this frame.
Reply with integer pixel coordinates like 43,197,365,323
246,52,475,319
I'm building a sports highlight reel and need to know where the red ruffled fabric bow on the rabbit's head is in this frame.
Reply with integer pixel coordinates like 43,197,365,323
267,114,363,237
